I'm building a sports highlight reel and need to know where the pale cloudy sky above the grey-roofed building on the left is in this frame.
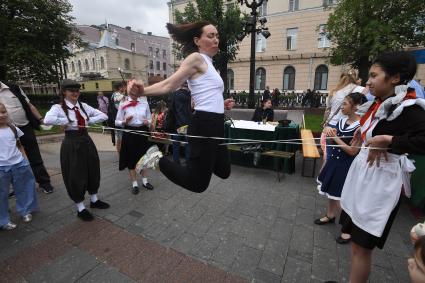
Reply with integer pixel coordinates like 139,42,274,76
68,0,169,37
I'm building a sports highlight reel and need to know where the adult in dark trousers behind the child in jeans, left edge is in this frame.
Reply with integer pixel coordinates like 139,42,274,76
0,81,53,194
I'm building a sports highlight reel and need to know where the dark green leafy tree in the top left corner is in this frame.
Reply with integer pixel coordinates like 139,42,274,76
0,0,79,83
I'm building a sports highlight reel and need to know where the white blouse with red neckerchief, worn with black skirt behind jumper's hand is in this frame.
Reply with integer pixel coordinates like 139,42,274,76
115,97,152,127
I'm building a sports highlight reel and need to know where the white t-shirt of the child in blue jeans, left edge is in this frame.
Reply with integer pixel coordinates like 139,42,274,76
0,127,24,166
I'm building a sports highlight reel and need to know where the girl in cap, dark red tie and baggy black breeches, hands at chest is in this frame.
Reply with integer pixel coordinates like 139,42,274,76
44,79,109,221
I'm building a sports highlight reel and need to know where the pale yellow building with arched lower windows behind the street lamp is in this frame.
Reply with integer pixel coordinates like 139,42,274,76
168,0,425,92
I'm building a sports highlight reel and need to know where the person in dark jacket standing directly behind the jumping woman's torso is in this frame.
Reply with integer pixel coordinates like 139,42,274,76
169,82,192,164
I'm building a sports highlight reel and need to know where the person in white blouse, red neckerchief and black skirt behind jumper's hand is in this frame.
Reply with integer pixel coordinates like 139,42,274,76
115,87,154,195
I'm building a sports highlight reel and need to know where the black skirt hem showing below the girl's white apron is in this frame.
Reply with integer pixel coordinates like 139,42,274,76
339,198,401,250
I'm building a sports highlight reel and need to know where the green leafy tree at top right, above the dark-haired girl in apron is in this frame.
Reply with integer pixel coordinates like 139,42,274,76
326,0,425,83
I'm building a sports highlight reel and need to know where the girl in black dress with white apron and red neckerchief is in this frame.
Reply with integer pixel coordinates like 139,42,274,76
340,51,425,283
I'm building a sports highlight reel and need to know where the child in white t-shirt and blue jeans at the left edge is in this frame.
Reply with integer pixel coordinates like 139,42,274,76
0,103,38,230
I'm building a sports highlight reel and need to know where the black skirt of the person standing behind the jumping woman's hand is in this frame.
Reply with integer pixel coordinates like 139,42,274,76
119,126,150,170
